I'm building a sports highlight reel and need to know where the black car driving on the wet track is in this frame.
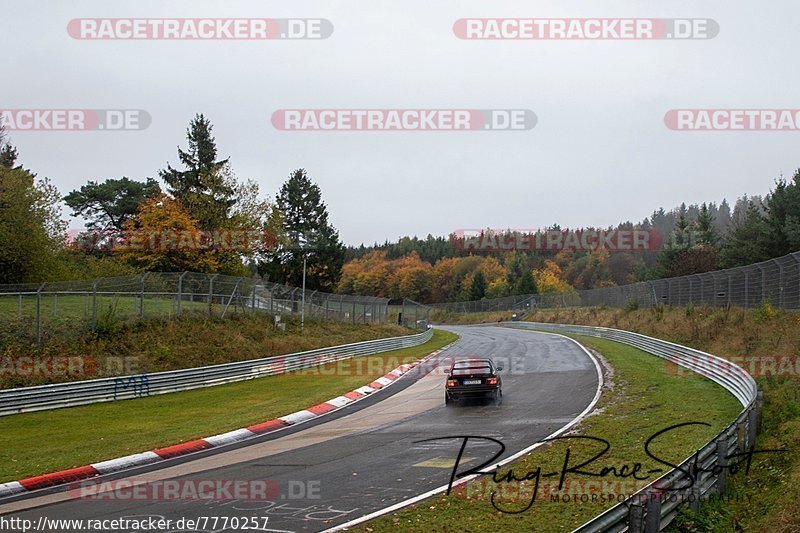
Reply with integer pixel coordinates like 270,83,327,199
444,358,503,405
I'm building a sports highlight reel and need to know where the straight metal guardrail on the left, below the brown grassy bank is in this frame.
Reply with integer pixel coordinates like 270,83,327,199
0,329,433,416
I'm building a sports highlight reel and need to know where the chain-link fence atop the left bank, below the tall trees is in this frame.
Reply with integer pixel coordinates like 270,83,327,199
0,272,389,344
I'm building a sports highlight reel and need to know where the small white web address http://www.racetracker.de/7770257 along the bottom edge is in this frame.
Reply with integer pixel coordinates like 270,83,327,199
0,516,268,533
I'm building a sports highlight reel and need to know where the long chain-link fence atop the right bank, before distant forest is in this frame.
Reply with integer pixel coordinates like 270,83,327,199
424,252,800,313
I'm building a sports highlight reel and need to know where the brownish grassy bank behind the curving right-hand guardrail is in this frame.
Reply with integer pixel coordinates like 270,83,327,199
526,304,800,533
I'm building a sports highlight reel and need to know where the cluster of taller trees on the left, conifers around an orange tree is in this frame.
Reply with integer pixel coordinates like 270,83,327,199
0,114,345,291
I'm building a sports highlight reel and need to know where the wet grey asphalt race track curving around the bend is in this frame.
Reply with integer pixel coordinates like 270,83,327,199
0,326,598,532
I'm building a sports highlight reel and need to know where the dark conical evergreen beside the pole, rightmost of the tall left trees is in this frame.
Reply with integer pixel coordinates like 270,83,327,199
259,168,345,291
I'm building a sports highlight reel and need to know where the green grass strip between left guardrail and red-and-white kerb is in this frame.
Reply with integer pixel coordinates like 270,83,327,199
0,330,457,482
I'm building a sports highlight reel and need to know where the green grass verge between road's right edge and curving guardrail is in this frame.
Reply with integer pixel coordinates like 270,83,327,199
359,336,741,532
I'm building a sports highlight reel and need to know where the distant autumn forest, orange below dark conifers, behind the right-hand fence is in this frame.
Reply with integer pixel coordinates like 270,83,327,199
338,170,800,303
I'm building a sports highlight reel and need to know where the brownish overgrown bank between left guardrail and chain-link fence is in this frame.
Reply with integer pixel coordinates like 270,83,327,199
0,314,412,388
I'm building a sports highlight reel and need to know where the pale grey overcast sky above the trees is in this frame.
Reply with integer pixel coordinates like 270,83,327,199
0,0,800,244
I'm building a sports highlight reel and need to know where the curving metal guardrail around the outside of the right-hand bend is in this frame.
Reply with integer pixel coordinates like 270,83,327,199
506,322,763,533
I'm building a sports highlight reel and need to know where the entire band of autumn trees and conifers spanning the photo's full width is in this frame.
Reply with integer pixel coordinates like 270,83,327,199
0,114,800,302
